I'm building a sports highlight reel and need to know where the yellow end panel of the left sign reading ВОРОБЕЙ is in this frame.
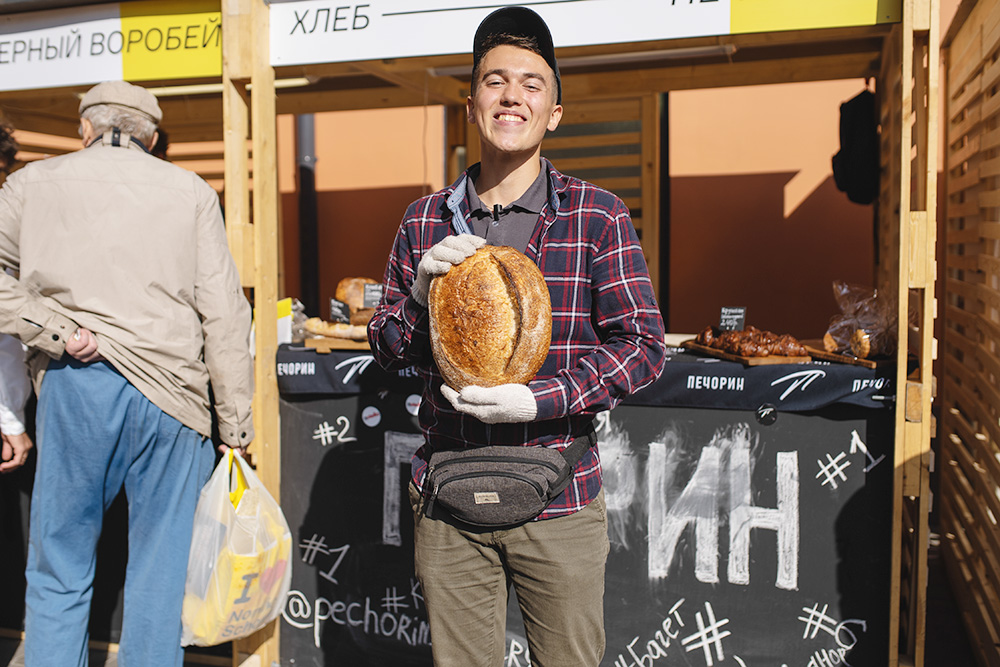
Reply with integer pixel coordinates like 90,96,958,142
120,0,222,81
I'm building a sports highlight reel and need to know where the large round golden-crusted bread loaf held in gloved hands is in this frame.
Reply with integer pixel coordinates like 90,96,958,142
428,246,552,390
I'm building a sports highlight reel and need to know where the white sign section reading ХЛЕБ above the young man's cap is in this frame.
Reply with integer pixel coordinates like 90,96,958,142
271,0,730,69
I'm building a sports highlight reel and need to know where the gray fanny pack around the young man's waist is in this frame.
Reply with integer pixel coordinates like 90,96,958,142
424,424,597,528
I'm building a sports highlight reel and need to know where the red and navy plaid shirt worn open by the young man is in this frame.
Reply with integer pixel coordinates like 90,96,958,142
368,159,665,519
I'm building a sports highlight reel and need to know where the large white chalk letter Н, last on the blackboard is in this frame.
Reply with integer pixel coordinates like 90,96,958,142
729,429,799,590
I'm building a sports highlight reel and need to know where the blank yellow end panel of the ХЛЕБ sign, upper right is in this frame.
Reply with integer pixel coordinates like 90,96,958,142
730,0,903,35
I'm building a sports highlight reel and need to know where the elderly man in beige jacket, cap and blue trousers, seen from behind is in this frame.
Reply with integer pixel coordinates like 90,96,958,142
0,81,253,667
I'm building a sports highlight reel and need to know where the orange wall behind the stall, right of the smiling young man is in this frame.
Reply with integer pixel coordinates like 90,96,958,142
661,79,874,338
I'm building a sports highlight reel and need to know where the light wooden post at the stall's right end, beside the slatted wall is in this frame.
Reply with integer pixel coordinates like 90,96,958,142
890,0,939,667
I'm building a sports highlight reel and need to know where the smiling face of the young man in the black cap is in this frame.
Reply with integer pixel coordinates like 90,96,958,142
467,44,562,160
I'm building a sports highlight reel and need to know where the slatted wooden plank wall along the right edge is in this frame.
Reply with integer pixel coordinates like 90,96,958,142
939,0,1000,665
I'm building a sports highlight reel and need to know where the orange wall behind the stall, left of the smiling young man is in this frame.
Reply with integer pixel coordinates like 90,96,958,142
278,107,444,317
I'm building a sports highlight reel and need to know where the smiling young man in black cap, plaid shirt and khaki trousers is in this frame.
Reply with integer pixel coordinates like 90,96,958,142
368,7,665,667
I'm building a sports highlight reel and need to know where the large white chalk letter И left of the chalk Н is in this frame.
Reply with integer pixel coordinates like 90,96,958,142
647,442,722,584
